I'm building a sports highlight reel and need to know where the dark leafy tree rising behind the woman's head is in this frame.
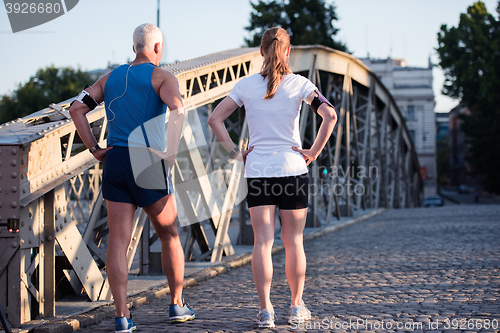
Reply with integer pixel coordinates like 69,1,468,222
245,0,347,52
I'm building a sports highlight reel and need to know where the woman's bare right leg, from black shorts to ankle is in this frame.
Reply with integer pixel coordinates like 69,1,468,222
280,208,307,305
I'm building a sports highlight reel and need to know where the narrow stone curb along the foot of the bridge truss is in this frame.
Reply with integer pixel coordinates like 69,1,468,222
28,208,385,333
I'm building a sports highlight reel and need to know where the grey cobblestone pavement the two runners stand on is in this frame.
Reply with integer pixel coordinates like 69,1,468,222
81,205,500,333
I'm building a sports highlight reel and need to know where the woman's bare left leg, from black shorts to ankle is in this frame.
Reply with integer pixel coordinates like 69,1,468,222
249,205,276,310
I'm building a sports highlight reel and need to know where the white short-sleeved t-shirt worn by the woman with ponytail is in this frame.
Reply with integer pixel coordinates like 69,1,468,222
229,73,317,178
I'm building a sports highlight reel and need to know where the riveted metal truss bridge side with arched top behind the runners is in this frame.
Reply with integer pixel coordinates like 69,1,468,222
0,46,422,327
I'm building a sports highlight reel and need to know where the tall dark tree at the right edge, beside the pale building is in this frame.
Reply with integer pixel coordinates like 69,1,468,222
437,1,500,193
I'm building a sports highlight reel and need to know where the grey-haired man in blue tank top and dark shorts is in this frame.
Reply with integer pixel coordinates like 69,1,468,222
69,24,195,332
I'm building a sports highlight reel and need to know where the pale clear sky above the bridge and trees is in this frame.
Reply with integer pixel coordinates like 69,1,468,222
0,0,498,112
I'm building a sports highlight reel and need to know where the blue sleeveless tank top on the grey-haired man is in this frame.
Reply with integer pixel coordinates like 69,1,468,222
104,63,167,151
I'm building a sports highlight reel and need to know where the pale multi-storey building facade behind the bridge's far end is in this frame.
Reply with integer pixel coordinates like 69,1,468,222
361,58,438,196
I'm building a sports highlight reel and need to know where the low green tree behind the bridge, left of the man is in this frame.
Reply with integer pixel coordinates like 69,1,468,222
0,66,93,124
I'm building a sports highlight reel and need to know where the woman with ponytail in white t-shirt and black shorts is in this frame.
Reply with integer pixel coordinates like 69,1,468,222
208,28,337,328
